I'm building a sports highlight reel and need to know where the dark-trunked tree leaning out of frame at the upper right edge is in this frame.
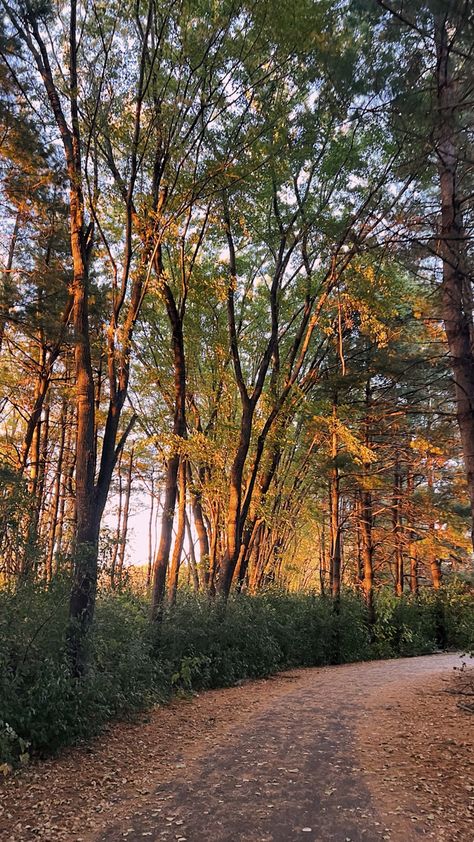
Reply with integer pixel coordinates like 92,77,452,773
370,0,474,542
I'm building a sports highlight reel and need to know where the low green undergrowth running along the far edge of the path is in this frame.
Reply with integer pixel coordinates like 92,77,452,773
0,579,474,765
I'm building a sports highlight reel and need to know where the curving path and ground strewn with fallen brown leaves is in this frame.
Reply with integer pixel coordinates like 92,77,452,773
0,654,474,842
